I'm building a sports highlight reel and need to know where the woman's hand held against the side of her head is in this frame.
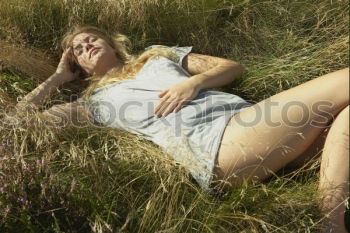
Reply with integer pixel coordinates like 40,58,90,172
55,48,80,84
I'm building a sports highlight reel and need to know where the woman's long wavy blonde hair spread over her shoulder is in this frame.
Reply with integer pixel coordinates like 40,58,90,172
61,26,179,100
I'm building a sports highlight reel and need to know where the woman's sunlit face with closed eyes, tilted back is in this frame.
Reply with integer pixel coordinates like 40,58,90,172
72,33,119,75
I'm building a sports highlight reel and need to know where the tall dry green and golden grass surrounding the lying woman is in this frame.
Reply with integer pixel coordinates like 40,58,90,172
0,0,349,233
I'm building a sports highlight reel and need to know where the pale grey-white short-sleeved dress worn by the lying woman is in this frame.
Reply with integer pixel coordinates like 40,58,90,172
81,46,252,192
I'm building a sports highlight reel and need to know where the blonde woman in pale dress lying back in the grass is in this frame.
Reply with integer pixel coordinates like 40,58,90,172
18,27,349,232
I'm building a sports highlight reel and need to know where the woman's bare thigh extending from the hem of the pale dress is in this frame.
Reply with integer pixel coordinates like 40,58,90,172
213,69,349,188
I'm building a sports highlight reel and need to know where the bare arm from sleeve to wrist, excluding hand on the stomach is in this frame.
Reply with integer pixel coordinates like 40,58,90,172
182,53,245,89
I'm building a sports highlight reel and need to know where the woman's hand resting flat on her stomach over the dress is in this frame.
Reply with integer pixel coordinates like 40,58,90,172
154,78,200,117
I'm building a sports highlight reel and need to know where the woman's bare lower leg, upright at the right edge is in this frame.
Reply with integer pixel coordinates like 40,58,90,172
319,106,349,233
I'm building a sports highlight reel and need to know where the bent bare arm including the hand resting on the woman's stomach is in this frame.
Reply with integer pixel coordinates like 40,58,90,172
154,53,245,117
